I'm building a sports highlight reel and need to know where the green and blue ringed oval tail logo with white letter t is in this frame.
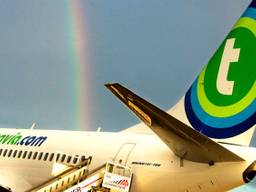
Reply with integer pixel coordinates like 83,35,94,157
185,0,256,139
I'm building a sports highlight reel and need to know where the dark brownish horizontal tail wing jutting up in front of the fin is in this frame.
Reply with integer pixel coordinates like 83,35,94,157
105,83,243,164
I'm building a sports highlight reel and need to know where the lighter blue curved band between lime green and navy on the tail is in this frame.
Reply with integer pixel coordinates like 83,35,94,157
190,81,256,128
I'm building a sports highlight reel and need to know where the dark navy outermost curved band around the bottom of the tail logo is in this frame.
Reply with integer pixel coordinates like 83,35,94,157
184,89,256,139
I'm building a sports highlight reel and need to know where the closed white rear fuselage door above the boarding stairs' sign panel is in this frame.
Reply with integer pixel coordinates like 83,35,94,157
114,143,136,166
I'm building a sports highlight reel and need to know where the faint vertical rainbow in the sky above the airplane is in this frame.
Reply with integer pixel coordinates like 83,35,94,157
65,0,92,130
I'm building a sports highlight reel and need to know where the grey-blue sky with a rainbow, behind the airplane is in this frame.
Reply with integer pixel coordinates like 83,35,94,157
0,0,252,191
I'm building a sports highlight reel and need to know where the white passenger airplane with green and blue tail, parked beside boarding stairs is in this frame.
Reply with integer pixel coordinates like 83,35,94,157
0,0,256,192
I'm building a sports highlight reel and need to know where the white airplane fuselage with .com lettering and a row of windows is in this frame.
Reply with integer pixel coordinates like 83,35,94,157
0,129,256,192
